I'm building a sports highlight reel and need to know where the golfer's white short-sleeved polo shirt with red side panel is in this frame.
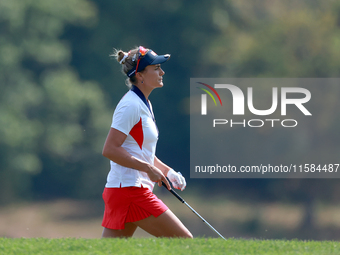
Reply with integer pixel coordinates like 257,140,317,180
105,88,158,191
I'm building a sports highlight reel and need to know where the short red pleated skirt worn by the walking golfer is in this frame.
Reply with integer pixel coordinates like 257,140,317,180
102,187,168,229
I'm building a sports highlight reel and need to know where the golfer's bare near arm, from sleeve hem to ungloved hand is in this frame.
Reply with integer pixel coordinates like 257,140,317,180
103,128,171,190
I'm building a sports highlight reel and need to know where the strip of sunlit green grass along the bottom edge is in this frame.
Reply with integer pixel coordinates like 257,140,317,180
0,238,340,255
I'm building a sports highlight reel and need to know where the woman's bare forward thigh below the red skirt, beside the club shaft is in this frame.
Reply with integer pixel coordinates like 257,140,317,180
133,210,192,238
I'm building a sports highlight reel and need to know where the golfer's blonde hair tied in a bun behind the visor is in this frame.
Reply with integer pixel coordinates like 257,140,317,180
110,47,139,88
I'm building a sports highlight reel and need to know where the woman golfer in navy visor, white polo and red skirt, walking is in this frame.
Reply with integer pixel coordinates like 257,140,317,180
102,46,192,238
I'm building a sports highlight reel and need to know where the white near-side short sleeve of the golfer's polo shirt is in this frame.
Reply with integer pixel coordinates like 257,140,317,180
111,101,141,135
